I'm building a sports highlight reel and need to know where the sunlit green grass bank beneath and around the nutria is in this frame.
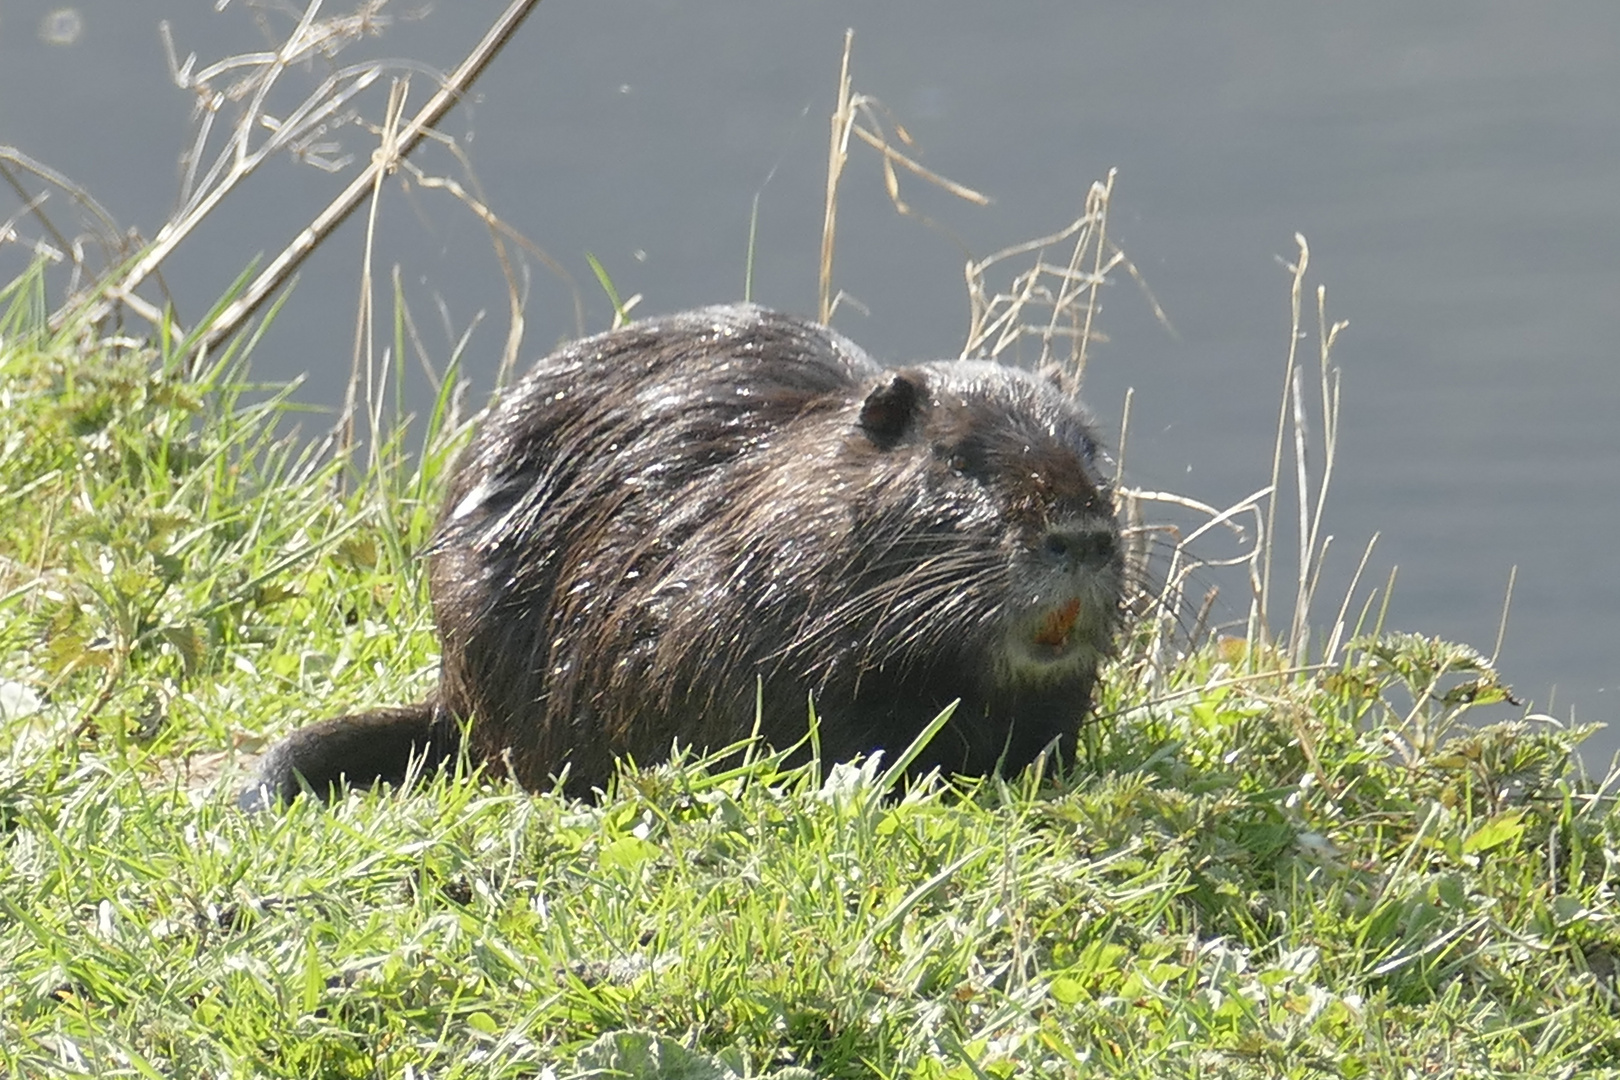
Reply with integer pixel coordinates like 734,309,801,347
0,263,1620,1080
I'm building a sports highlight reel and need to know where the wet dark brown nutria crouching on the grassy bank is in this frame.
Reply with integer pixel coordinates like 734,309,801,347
241,304,1124,806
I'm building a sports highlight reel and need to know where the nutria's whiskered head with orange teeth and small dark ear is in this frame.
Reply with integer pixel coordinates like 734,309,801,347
852,361,1124,695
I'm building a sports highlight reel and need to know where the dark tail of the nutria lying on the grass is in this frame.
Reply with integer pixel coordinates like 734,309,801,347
237,701,462,811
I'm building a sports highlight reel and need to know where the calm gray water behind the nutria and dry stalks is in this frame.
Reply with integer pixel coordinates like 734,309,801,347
0,0,1620,764
